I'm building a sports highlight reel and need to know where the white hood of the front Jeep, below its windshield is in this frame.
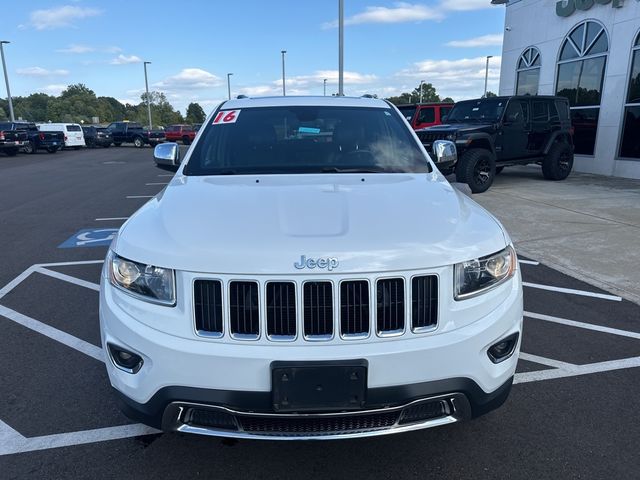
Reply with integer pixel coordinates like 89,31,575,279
112,173,506,275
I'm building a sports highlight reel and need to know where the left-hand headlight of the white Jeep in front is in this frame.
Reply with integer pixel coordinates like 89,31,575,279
108,252,176,305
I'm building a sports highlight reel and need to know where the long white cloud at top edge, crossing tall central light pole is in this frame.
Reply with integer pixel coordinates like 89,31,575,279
322,0,442,28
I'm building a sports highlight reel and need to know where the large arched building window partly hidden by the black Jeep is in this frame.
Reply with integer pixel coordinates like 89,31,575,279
556,21,609,155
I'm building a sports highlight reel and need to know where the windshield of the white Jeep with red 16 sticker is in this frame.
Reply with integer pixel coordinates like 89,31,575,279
184,106,431,175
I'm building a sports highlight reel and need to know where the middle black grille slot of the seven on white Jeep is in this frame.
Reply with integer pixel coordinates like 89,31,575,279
302,282,333,339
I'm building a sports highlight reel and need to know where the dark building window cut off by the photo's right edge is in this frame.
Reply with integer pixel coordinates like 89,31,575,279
620,33,640,158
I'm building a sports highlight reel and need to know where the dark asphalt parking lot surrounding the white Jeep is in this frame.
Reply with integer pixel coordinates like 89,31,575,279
0,147,640,479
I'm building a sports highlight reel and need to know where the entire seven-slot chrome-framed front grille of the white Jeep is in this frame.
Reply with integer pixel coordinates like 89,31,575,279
192,274,439,342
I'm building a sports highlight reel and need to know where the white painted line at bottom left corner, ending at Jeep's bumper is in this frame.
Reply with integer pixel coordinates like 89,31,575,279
0,421,161,455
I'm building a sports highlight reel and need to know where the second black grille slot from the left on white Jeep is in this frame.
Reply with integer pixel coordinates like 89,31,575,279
229,282,260,338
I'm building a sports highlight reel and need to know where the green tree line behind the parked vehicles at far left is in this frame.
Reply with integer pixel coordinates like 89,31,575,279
0,83,206,126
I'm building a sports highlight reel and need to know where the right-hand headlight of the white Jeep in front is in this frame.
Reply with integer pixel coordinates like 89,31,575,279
454,246,517,300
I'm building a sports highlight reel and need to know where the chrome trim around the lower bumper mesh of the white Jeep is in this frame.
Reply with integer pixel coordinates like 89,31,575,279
163,393,471,440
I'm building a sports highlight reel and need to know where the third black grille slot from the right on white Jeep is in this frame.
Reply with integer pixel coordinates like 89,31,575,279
340,280,369,337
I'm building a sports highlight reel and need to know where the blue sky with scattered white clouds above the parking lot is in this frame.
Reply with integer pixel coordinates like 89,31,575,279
0,0,505,112
